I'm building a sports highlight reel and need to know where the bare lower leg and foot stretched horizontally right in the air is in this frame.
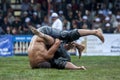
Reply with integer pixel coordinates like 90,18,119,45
78,29,104,42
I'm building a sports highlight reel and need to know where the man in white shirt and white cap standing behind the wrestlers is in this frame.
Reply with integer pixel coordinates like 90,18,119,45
51,13,63,30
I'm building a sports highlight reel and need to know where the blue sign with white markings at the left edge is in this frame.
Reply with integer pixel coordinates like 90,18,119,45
0,35,13,56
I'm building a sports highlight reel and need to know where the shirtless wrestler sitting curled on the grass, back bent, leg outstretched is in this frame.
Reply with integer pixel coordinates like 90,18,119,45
28,30,86,70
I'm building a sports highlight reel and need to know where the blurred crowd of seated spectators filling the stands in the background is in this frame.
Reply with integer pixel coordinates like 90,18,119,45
0,0,120,35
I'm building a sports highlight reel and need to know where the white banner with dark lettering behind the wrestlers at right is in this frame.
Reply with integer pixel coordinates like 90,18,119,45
77,34,120,56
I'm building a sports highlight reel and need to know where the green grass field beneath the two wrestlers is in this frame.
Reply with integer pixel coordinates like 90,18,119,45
0,56,120,80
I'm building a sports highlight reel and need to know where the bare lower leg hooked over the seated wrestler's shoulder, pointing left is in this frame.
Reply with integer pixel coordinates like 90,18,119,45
29,26,54,45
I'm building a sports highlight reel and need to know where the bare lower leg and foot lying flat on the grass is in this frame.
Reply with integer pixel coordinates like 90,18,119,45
65,62,86,70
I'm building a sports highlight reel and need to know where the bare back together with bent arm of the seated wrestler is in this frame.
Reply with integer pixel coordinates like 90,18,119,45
28,35,60,67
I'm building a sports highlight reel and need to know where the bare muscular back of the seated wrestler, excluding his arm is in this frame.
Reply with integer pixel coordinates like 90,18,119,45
28,35,47,66
